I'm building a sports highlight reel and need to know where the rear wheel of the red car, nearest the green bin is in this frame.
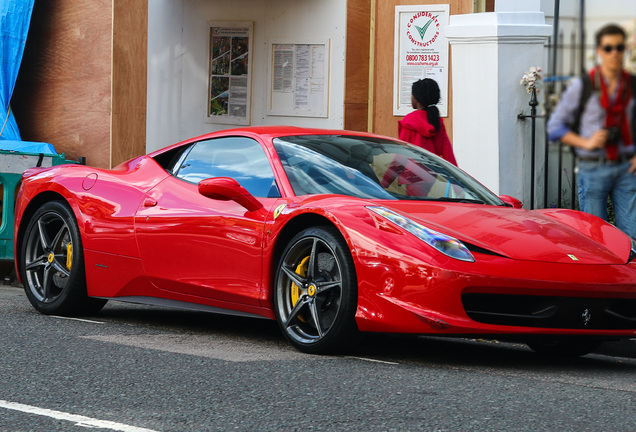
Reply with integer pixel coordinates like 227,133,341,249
20,201,106,316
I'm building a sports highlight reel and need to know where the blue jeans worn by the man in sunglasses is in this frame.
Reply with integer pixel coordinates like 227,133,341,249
577,162,636,239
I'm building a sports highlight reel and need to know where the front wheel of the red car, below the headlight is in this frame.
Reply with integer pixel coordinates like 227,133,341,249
274,227,358,354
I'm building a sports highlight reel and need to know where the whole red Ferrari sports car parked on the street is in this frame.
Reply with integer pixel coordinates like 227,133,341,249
15,127,636,355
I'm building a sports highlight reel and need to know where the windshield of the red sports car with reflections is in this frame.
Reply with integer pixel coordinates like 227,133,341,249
274,135,503,205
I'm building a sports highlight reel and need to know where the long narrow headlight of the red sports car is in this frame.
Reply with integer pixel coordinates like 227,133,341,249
367,206,475,262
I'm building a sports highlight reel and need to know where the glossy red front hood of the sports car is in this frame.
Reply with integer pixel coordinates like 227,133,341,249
383,202,630,264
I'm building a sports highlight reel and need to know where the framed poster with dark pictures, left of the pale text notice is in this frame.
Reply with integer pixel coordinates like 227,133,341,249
207,21,252,125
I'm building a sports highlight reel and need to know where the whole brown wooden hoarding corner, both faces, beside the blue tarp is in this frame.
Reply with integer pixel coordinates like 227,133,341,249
11,0,148,168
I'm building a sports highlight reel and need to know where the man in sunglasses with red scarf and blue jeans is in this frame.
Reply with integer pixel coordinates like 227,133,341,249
547,24,636,238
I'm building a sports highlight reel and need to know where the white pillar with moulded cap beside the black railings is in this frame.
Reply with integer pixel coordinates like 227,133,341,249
445,11,552,207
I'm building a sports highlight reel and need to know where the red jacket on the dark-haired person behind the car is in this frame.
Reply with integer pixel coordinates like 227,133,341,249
398,110,457,166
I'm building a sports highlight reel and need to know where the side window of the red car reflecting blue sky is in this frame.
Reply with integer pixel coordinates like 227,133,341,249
174,137,280,198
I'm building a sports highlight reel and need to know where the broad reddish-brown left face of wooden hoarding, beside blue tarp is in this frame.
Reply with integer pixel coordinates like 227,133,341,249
12,0,112,167
